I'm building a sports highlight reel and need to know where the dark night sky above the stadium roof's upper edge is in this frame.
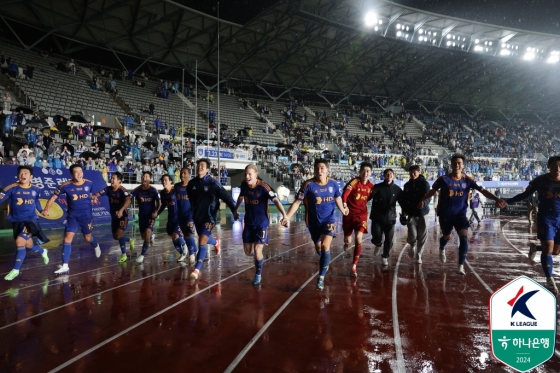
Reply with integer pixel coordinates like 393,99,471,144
183,0,560,34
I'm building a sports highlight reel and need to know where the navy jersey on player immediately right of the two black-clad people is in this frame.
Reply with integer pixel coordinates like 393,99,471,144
432,174,484,216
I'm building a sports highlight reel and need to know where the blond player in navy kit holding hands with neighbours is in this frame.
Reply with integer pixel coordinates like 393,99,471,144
235,164,288,285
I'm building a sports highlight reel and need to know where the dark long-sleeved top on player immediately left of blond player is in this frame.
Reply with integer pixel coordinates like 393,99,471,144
187,175,235,224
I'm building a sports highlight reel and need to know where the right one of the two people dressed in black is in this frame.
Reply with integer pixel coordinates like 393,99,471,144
401,165,430,264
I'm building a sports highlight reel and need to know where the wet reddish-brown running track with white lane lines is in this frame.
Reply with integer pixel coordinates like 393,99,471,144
0,213,560,372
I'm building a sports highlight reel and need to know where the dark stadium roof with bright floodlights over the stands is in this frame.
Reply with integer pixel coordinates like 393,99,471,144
0,0,560,114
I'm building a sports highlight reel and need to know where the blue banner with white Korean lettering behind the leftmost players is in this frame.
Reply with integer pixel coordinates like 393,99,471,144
0,166,111,228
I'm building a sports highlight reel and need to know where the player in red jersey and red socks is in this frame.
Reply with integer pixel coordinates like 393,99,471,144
342,162,374,276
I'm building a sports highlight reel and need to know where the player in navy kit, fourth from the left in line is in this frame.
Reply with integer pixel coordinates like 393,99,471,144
131,171,161,263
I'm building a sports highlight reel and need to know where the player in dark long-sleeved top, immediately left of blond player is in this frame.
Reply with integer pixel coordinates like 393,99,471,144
187,158,239,280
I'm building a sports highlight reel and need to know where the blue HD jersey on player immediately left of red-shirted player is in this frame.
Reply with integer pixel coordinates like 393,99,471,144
297,178,340,227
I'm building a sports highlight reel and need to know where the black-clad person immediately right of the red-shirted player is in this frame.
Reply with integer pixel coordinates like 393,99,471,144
369,168,402,266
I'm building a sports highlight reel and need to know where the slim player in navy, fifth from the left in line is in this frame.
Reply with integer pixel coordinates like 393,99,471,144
158,175,187,262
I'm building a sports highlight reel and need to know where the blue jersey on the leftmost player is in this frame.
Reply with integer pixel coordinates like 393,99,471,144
0,183,43,222
